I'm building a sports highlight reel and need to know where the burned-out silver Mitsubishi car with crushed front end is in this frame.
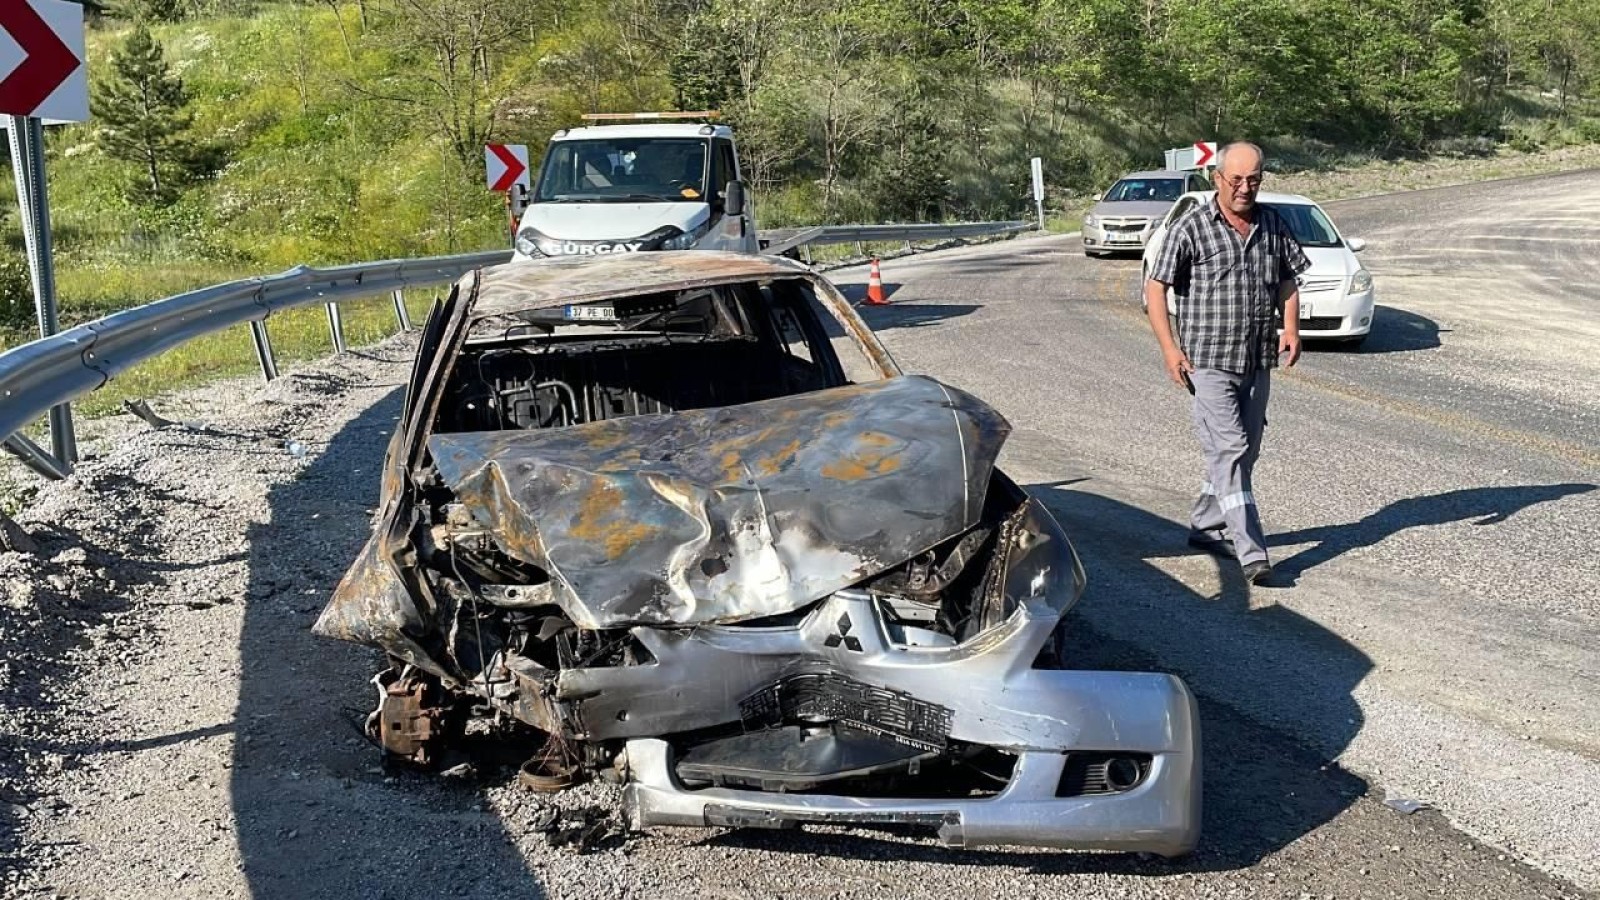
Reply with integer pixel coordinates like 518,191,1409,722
315,251,1200,855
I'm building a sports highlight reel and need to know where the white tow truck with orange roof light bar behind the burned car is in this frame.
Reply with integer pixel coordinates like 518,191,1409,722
515,112,760,259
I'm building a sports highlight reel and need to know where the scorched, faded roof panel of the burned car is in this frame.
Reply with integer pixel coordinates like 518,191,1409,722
461,250,816,319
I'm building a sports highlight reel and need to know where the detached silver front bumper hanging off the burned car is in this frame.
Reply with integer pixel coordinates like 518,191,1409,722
624,669,1200,857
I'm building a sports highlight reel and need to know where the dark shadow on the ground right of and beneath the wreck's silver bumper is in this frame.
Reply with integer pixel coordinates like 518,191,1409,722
702,484,1373,878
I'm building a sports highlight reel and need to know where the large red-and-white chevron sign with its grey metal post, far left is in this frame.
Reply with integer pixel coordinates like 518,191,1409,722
0,0,90,469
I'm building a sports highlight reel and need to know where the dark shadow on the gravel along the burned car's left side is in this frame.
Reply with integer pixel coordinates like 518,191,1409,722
232,376,547,900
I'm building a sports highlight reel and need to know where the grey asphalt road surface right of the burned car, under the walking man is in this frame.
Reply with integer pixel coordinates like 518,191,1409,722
838,173,1600,886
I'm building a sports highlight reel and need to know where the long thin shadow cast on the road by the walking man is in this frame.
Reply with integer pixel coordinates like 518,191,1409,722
1270,484,1595,583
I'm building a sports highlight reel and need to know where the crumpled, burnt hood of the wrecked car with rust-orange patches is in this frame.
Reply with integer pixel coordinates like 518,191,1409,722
429,373,1010,628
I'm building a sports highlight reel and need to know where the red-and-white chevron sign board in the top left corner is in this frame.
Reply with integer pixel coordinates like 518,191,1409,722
0,0,90,122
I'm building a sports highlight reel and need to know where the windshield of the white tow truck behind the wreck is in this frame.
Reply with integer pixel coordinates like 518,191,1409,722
533,138,709,203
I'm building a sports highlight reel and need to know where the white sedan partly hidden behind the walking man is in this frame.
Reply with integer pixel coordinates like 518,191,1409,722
1139,191,1376,346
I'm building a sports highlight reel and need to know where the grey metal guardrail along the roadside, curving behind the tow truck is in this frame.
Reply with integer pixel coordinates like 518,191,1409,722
0,221,1034,479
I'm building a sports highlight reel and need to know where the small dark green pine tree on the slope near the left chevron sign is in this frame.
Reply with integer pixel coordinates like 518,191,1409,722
93,22,190,200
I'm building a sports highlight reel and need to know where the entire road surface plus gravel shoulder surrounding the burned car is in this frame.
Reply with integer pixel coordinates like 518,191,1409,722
0,176,1600,900
